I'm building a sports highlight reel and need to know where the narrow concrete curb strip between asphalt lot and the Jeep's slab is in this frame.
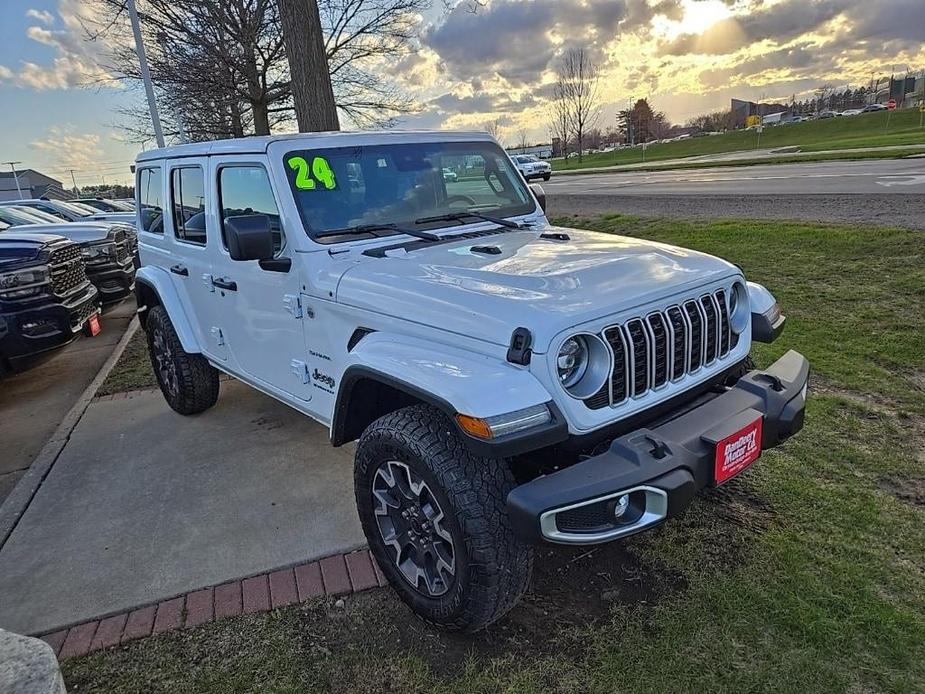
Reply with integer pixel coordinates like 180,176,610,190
0,316,139,549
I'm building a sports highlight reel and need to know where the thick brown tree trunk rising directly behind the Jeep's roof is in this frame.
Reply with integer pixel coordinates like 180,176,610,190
277,0,340,133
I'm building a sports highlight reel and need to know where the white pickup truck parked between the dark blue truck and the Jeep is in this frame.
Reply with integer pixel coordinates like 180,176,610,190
0,213,138,304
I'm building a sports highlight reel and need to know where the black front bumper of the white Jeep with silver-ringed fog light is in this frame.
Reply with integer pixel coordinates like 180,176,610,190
507,351,809,544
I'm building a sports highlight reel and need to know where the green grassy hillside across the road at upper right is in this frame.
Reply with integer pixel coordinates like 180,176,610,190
552,109,925,171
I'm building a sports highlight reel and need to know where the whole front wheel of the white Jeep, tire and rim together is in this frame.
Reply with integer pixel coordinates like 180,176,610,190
354,405,533,632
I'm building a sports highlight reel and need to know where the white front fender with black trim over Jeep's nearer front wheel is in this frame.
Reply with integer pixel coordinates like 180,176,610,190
331,332,568,457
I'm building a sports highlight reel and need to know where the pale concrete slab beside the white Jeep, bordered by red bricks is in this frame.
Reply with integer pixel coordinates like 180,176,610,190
0,381,364,633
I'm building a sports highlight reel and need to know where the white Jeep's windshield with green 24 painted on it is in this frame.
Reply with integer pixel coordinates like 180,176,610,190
283,141,535,241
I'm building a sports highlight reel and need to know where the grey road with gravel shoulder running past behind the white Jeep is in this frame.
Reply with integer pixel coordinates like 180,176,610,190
543,158,925,229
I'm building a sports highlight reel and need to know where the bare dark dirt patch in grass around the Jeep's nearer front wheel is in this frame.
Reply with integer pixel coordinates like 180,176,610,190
302,542,686,677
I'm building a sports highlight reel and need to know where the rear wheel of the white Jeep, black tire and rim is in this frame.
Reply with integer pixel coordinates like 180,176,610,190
145,306,218,415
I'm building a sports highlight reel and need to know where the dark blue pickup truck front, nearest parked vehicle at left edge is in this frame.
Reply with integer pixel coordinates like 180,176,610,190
0,231,100,375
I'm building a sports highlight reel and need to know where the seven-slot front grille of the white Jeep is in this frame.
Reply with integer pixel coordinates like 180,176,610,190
584,289,738,410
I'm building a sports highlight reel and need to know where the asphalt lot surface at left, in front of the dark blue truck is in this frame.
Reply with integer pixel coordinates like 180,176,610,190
0,298,135,502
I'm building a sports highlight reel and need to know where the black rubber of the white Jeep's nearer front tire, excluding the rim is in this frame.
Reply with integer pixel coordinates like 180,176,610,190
354,405,533,632
